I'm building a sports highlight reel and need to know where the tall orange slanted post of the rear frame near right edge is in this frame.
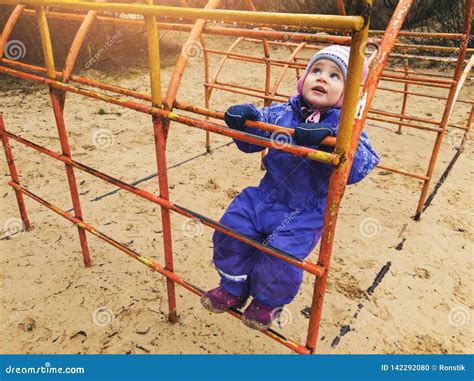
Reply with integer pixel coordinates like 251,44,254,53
415,0,473,221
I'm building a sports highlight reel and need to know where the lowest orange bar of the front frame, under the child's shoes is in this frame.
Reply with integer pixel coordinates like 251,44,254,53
8,181,309,354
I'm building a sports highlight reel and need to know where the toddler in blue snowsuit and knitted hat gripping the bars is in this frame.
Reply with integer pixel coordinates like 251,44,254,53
201,45,380,330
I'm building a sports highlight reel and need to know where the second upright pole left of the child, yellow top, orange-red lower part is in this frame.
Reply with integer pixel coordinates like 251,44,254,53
36,7,92,267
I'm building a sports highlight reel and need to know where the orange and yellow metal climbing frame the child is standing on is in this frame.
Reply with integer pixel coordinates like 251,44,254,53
0,0,462,354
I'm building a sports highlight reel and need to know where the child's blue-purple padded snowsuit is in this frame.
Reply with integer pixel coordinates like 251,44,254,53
213,96,380,307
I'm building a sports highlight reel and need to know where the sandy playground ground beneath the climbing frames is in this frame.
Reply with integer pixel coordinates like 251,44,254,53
0,34,474,353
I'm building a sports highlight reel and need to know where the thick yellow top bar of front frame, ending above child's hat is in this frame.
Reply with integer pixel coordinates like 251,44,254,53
0,0,364,31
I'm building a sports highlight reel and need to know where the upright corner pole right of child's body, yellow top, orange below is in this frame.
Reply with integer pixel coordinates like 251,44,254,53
306,0,372,353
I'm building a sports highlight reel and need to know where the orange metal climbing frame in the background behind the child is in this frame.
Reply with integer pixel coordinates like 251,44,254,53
203,0,474,220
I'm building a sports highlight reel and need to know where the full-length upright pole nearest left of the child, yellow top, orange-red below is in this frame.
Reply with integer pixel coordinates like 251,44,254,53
145,0,177,323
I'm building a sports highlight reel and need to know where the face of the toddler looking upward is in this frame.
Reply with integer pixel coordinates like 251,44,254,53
302,59,344,109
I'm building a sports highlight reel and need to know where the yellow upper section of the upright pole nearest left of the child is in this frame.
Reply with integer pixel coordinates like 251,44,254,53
145,0,161,107
